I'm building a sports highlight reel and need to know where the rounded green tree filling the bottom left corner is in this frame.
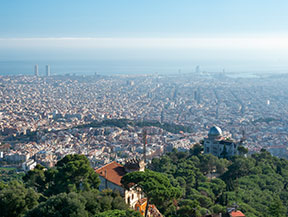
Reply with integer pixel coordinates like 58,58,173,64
0,181,39,217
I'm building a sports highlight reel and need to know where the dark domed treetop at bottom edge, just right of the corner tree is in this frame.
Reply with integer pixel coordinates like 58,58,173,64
26,192,88,217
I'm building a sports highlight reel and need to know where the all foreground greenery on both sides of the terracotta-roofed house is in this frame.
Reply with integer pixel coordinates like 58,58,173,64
0,151,288,217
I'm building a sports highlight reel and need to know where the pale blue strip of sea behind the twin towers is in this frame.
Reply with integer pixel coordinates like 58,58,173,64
0,60,288,78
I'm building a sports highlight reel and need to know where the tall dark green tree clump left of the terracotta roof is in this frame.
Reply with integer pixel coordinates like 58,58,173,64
23,154,100,196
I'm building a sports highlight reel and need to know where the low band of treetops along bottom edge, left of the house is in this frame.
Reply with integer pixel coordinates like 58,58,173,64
27,190,133,217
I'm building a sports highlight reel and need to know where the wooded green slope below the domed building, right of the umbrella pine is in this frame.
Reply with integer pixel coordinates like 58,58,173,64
149,146,288,217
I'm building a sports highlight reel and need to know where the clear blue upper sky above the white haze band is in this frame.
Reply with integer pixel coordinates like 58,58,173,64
0,0,288,37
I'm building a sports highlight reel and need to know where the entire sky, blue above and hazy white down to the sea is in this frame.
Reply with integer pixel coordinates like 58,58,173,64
0,0,288,73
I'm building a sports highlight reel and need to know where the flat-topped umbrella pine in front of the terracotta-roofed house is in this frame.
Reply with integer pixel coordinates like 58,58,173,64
121,170,181,216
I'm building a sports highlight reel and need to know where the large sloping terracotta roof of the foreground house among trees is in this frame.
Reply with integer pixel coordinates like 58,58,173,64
95,161,126,186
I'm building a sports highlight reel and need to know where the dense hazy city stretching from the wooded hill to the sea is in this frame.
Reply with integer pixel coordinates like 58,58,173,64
0,71,288,169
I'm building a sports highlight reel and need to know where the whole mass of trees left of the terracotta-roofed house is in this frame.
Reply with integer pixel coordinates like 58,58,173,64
0,155,140,217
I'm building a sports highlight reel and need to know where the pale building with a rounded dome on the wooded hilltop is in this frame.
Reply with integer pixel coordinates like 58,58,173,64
204,126,239,158
